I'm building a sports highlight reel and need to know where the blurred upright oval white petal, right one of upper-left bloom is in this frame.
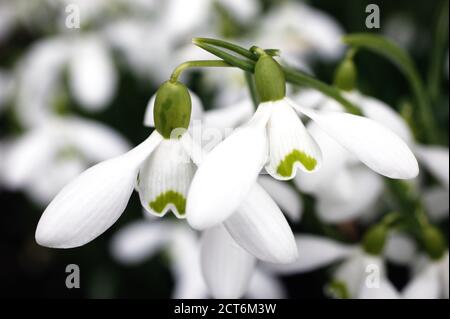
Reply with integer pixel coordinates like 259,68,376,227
69,37,117,111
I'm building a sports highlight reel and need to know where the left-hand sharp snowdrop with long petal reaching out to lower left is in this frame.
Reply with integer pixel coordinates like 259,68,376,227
36,81,201,248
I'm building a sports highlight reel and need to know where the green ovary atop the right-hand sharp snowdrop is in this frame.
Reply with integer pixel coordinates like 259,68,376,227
255,54,286,102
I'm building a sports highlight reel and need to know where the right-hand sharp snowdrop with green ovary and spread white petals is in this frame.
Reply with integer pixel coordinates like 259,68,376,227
187,53,418,229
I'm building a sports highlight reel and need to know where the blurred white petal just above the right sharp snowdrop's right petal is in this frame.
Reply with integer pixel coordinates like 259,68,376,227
350,92,414,145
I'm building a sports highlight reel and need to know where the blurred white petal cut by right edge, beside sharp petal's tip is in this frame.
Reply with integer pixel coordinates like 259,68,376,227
415,145,449,188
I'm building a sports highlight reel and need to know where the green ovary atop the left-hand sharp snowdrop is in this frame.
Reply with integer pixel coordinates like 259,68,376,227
153,81,191,138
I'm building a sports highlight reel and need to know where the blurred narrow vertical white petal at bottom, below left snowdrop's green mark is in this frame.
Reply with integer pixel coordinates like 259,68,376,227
169,223,208,299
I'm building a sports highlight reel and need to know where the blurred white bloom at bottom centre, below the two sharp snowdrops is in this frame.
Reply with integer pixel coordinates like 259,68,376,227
111,219,285,299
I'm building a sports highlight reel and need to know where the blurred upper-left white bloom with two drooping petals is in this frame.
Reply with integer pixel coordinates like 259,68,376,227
16,34,117,126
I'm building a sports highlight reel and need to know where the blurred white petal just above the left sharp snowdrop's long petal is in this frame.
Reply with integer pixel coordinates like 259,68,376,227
60,117,130,162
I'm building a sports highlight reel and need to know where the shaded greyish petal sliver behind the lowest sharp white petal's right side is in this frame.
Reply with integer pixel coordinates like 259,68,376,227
258,176,303,222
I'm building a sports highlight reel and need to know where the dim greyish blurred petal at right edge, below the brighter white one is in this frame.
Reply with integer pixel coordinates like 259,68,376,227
423,186,449,221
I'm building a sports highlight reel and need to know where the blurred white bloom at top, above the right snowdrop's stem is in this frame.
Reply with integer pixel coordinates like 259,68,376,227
255,1,344,67
